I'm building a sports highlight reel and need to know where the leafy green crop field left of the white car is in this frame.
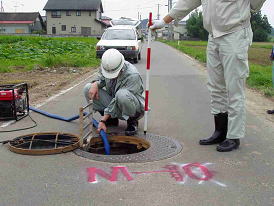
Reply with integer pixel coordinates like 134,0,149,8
0,36,99,73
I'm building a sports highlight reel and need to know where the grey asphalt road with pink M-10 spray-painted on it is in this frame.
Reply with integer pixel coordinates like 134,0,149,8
0,42,274,206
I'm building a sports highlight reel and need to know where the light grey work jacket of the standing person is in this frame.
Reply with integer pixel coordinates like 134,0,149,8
169,0,266,38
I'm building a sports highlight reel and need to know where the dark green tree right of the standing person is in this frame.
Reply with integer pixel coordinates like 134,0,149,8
251,11,272,42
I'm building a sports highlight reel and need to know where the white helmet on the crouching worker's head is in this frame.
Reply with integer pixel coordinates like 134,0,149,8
101,49,125,79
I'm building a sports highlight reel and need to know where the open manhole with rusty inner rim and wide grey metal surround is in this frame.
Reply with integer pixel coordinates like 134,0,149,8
74,133,182,163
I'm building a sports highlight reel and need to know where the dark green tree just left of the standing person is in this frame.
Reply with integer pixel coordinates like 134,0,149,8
186,10,208,40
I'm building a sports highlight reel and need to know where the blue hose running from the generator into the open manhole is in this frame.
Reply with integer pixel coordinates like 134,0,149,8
29,106,110,155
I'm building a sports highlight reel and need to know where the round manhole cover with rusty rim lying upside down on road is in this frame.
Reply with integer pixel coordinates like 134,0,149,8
9,132,80,155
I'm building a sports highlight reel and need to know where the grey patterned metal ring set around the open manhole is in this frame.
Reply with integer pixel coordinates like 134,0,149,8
73,133,183,163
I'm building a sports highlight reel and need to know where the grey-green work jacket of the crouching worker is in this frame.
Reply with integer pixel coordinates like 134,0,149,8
95,61,145,115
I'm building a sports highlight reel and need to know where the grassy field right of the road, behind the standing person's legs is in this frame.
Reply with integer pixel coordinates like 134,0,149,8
161,40,274,97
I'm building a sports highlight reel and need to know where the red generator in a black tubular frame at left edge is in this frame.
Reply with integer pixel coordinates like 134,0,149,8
0,83,29,121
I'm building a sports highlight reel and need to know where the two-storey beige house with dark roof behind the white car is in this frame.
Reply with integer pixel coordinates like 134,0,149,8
44,0,107,36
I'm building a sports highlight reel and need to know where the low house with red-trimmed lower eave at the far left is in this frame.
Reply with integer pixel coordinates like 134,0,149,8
0,12,46,34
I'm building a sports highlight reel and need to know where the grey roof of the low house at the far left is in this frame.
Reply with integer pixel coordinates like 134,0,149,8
0,12,40,23
